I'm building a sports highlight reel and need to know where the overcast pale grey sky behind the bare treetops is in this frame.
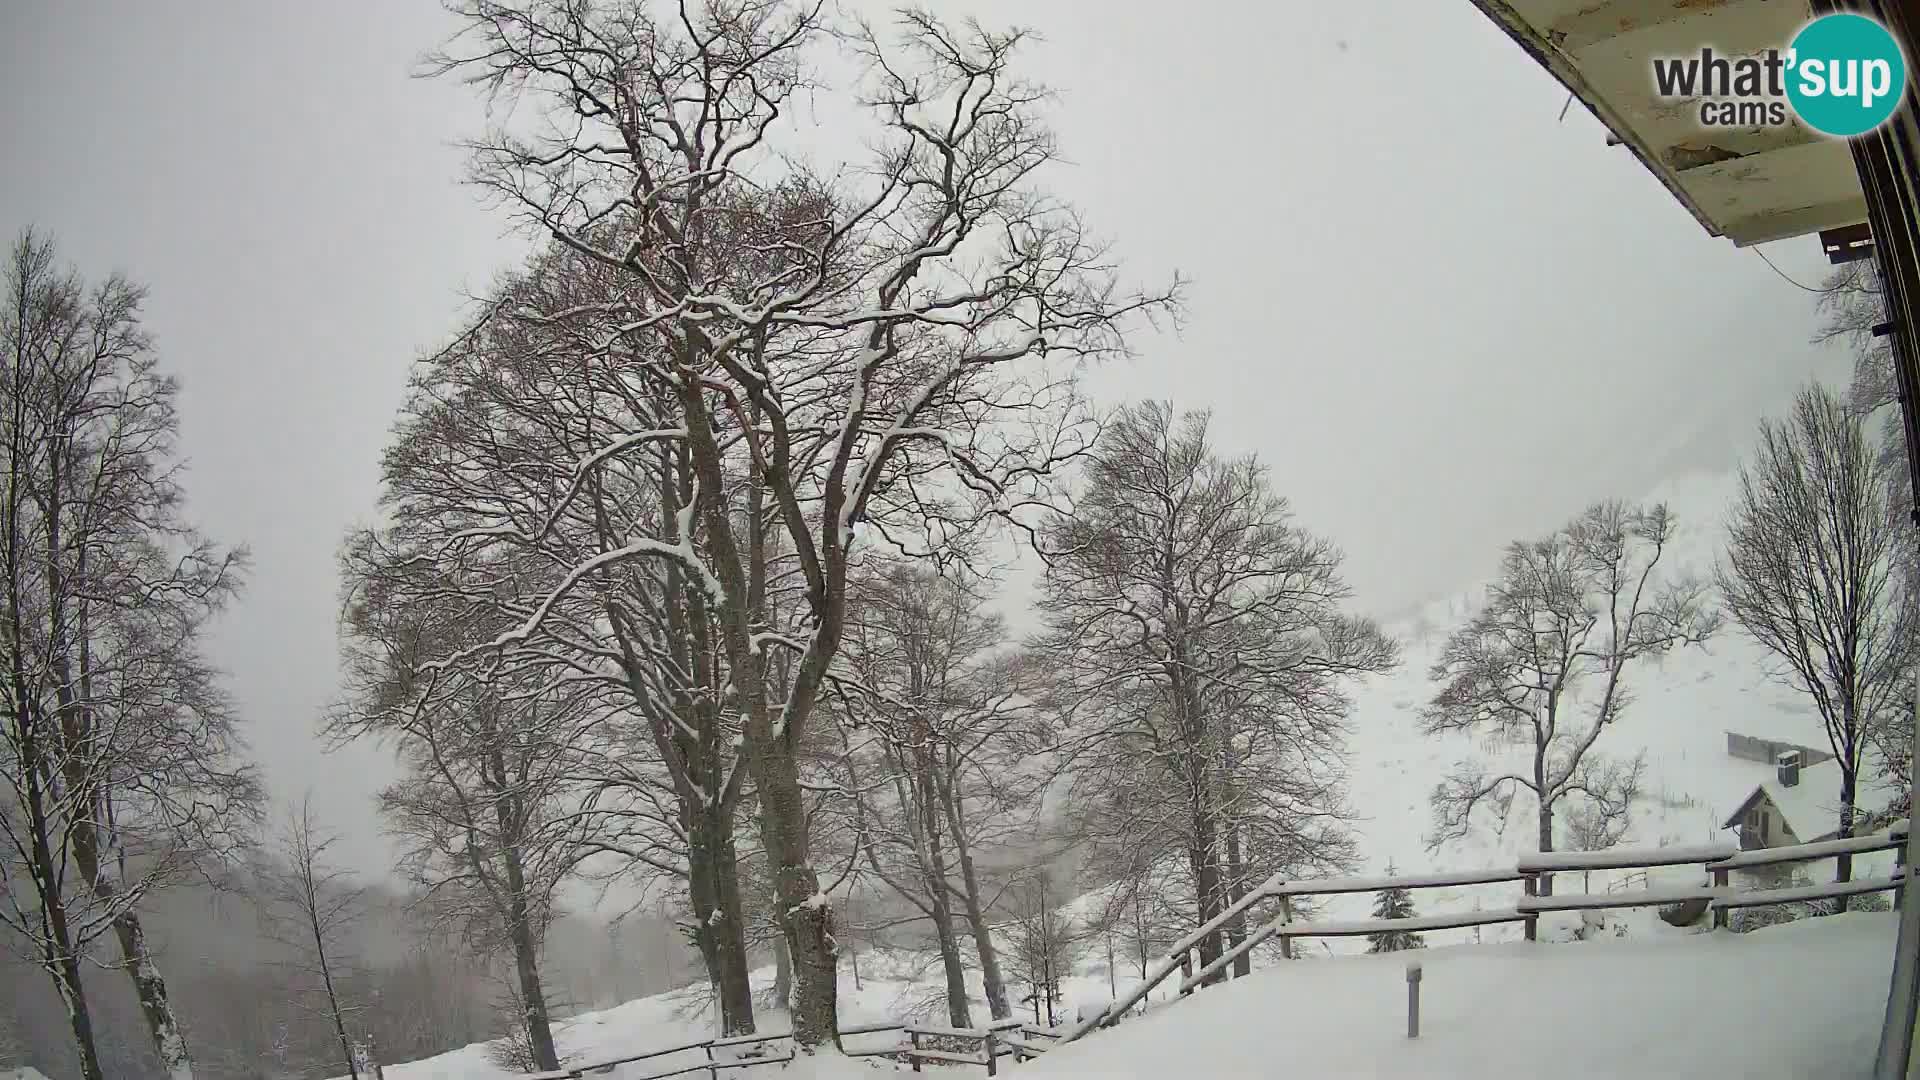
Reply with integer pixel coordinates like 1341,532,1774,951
0,0,1847,869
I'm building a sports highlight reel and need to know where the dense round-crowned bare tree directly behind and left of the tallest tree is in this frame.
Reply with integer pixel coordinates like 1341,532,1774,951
364,246,764,1034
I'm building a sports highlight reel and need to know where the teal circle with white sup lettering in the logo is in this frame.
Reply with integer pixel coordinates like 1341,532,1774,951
1788,15,1907,138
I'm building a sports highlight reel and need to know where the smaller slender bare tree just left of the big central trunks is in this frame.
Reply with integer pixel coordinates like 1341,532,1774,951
326,534,607,1070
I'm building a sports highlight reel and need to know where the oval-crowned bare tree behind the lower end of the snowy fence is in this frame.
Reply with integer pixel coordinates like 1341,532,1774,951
1035,402,1396,972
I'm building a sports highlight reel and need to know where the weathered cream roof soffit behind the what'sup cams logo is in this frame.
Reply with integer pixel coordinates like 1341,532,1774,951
1473,0,1866,244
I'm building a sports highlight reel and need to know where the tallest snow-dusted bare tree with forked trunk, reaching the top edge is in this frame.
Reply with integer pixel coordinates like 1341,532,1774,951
420,0,1167,1047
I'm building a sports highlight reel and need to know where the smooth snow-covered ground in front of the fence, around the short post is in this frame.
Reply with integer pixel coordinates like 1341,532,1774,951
1016,913,1895,1080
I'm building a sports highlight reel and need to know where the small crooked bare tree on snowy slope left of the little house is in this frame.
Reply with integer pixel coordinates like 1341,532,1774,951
1421,502,1718,894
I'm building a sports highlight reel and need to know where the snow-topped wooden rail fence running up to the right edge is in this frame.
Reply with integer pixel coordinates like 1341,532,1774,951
1054,821,1908,1045
